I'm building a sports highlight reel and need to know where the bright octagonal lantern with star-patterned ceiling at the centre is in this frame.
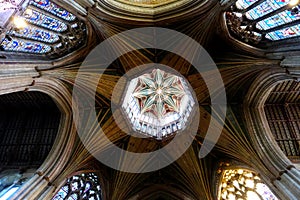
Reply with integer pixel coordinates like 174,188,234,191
122,69,195,139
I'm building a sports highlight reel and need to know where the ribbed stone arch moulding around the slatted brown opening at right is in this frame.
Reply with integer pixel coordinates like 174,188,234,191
244,68,300,199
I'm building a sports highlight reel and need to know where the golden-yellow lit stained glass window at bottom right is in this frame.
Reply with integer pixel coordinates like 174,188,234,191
218,169,278,200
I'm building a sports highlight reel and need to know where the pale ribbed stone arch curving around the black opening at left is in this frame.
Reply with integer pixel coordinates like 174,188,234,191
1,77,77,199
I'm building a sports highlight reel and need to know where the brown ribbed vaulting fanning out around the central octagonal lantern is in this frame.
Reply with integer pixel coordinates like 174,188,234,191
0,0,299,200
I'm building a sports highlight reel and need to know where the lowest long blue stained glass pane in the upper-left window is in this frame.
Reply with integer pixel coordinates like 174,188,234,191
0,38,51,54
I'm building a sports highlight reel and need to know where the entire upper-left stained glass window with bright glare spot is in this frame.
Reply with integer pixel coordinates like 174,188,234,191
0,0,86,57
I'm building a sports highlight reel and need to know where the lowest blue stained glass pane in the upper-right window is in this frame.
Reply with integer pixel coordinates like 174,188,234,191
266,24,300,41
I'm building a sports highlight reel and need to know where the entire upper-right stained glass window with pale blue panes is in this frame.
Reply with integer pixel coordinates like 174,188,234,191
226,0,300,44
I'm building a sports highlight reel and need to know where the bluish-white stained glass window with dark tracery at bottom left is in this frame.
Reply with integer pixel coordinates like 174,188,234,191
52,173,102,200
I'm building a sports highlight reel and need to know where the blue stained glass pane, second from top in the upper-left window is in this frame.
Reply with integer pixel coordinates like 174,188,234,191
23,10,68,32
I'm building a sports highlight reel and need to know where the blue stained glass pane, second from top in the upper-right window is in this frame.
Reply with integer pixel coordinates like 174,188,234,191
246,0,290,20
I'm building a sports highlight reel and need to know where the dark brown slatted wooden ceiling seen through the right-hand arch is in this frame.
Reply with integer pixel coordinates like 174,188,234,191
264,80,300,164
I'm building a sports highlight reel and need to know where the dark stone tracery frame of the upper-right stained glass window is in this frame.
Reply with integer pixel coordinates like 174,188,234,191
225,0,300,49
